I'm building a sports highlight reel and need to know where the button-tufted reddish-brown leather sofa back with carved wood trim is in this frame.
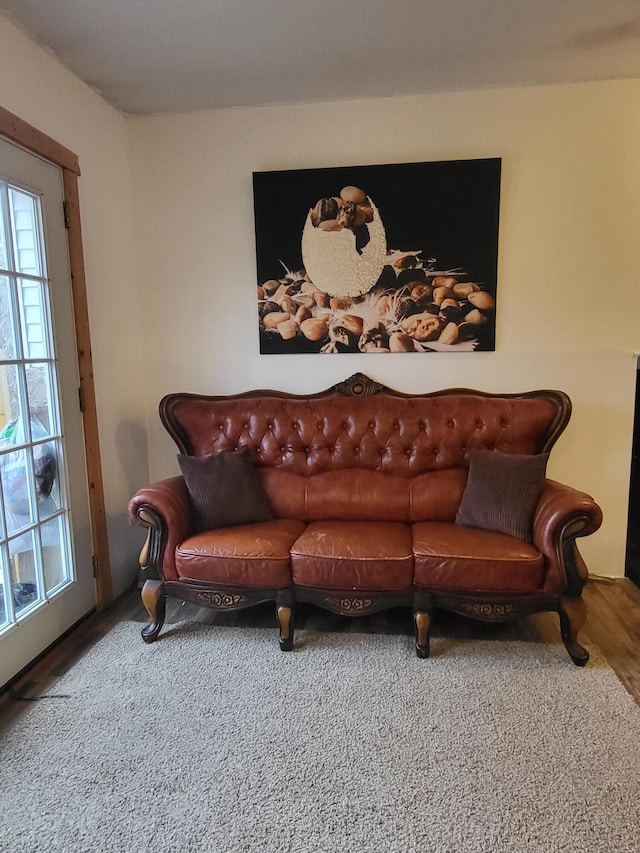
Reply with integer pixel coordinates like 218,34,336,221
160,374,571,521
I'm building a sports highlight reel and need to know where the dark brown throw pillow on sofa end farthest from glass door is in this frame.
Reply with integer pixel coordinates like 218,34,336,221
456,448,549,542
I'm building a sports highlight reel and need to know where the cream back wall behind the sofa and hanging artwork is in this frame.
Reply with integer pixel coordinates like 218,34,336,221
129,81,640,575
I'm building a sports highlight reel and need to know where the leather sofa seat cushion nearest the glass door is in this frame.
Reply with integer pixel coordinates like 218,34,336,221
176,518,304,588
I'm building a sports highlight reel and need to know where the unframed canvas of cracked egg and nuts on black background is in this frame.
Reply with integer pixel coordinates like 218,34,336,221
253,158,501,354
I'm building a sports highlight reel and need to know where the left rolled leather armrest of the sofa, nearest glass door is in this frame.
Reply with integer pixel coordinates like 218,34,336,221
129,477,193,580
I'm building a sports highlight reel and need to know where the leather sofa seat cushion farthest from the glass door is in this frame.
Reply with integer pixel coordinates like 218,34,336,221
412,521,544,592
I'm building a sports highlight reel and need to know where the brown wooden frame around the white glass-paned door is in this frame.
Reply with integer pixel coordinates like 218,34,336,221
0,107,113,610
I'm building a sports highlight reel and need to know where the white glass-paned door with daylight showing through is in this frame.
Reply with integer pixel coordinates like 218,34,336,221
0,140,95,686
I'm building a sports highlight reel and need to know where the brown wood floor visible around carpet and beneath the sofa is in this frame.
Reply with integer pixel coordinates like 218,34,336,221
0,578,640,731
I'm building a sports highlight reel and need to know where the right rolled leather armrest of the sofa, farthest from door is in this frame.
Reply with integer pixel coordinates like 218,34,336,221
533,480,602,596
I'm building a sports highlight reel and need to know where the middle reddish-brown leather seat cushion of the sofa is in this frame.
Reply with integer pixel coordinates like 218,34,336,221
291,521,413,590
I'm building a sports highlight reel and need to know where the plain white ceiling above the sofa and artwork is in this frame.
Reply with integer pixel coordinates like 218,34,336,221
0,0,640,115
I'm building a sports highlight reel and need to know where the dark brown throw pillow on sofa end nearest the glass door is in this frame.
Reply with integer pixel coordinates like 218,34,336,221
178,448,273,532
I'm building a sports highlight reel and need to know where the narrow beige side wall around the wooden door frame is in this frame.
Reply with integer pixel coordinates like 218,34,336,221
0,18,148,593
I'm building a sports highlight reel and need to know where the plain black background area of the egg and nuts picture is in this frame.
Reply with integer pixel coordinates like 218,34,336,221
253,158,501,351
